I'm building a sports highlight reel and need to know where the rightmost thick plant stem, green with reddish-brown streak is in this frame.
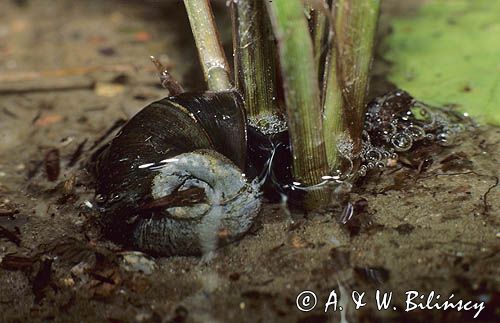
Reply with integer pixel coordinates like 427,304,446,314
324,0,380,168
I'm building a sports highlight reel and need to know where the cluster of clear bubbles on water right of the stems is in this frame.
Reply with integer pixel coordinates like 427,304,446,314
320,91,467,184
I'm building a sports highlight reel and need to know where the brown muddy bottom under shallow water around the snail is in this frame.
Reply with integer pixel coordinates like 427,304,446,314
0,0,500,322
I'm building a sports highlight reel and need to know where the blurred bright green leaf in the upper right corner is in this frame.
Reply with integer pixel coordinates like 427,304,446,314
385,0,500,125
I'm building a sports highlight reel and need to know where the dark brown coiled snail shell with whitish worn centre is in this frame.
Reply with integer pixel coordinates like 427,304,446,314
95,91,261,255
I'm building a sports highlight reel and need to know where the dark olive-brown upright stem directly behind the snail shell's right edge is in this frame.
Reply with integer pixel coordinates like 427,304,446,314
231,0,281,120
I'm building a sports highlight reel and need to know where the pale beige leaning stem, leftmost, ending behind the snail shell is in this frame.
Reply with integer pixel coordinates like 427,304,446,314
184,0,232,91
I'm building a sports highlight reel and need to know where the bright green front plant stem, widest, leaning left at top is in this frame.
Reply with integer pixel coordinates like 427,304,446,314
266,0,327,207
